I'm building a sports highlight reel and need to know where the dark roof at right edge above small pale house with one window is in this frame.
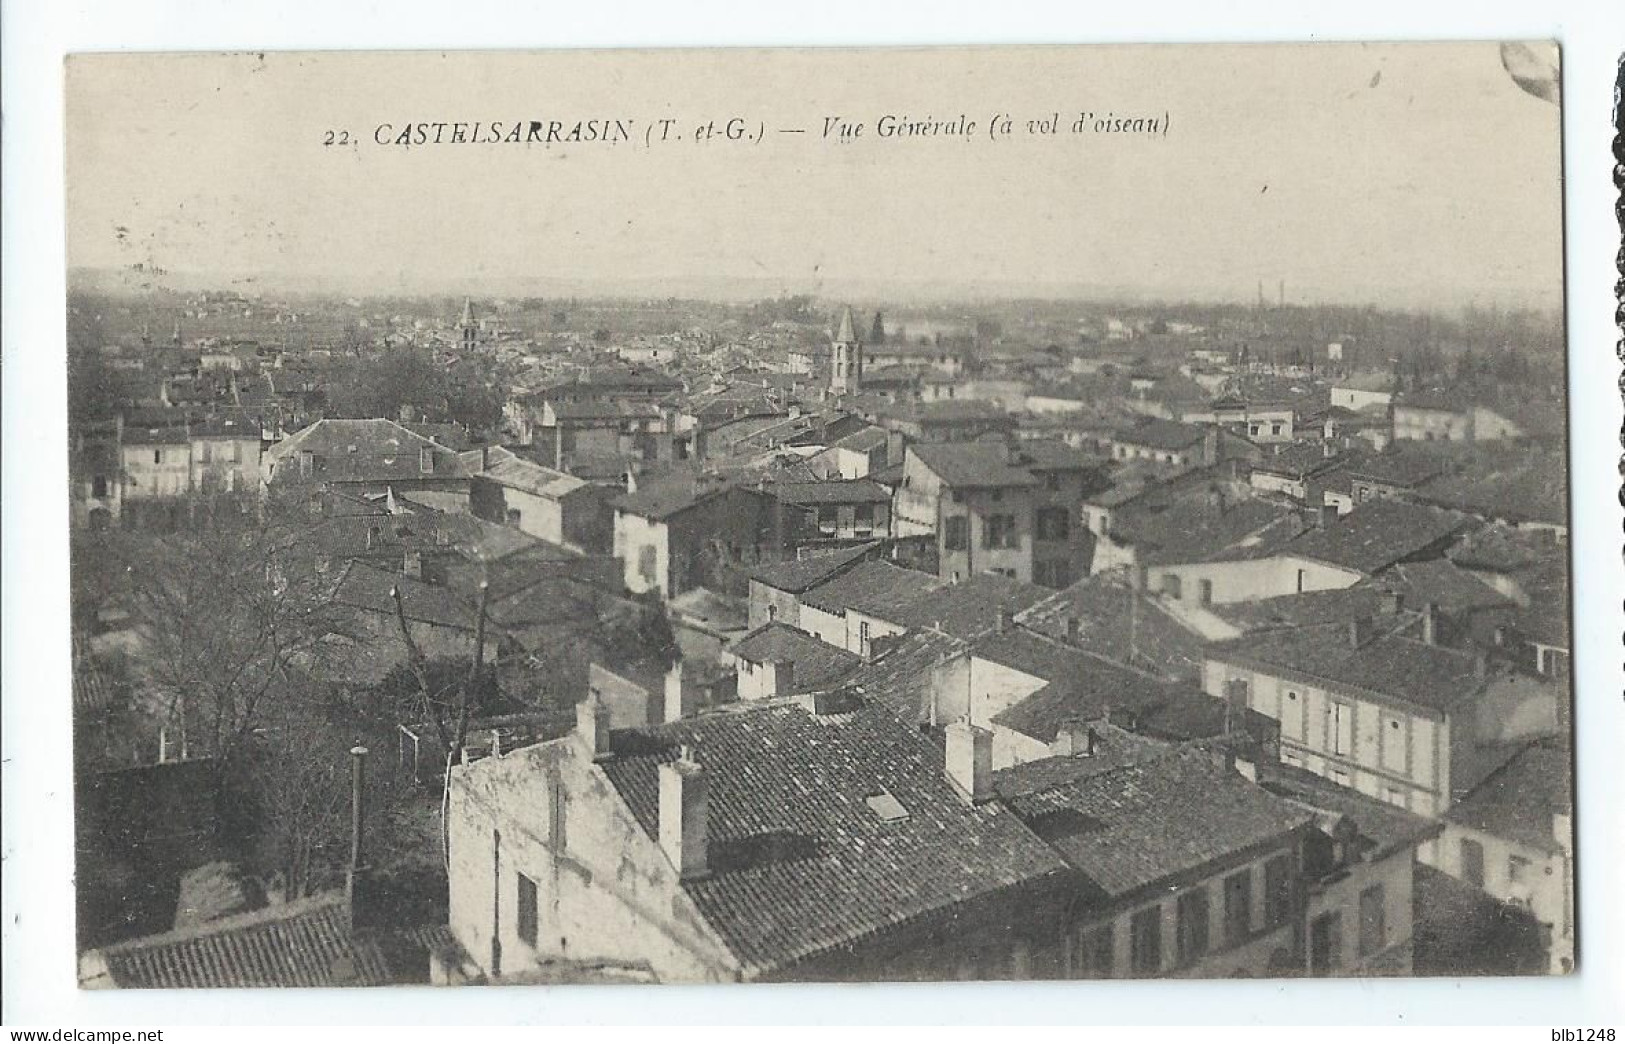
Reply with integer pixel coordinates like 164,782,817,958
1445,738,1573,852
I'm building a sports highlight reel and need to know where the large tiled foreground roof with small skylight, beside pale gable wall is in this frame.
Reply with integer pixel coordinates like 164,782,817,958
603,701,1064,977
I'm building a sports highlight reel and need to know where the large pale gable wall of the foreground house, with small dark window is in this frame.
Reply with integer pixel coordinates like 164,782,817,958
447,735,736,982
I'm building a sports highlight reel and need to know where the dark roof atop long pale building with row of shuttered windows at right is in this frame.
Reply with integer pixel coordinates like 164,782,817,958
1209,624,1489,711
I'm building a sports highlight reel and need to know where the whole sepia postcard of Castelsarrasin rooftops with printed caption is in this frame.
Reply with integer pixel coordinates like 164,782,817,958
57,41,1579,988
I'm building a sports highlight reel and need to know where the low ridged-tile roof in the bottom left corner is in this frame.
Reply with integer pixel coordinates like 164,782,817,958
96,894,450,989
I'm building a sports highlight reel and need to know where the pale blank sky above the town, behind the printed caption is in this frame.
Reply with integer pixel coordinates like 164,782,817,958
67,44,1562,309
